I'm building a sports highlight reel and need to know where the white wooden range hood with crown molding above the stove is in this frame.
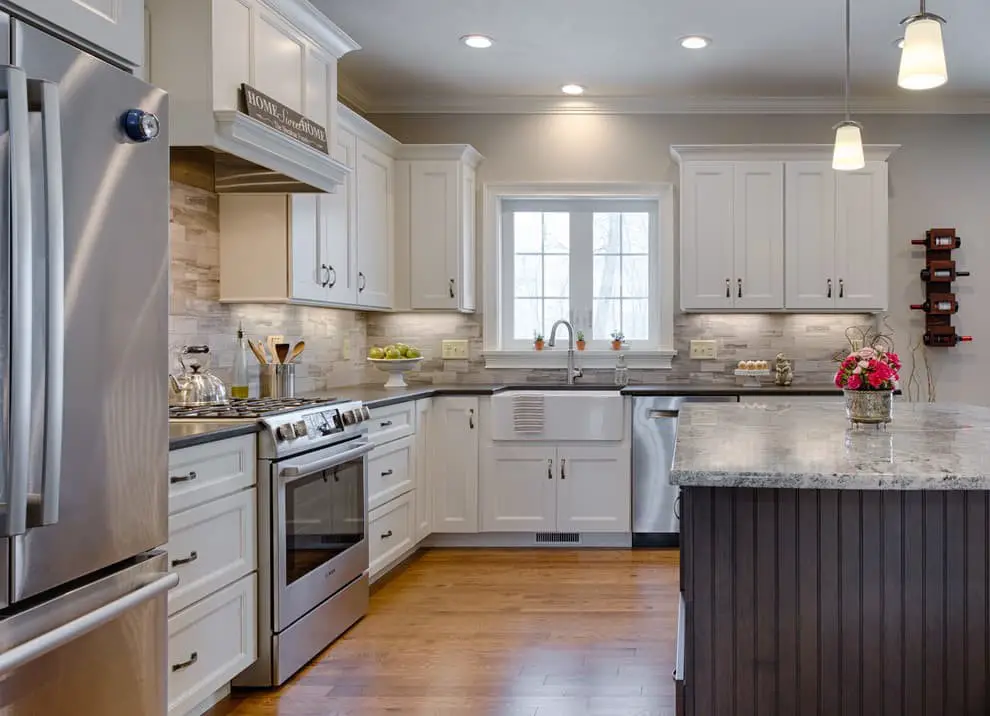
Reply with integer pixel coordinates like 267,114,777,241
147,0,358,192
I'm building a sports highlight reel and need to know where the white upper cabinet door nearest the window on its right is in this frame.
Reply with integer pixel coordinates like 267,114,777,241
681,163,734,310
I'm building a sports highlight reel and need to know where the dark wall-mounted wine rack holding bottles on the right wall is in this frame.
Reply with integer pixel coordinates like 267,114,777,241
911,229,973,348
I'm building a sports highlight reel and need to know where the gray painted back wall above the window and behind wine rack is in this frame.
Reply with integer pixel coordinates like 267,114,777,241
369,115,990,404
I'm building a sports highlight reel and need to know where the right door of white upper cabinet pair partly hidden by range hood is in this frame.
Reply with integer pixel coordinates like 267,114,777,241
320,132,357,305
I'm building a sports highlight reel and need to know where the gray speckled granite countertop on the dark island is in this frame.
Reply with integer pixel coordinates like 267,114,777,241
670,401,990,490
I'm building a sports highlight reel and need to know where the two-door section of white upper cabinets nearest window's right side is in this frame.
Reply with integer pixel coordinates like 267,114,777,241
681,162,784,311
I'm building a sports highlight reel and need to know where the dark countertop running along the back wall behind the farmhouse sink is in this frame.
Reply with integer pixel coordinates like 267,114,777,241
303,383,841,408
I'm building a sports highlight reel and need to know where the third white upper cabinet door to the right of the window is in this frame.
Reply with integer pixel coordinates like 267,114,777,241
784,162,838,310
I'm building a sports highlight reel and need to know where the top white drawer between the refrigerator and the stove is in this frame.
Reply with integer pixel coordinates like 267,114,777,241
168,435,256,515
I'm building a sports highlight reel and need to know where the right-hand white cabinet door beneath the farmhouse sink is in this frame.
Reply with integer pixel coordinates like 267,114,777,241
557,446,632,532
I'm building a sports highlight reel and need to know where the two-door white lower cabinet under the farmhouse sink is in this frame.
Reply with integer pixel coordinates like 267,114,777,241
480,445,631,532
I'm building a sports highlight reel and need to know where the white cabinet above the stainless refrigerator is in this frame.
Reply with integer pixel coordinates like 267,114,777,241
10,0,144,67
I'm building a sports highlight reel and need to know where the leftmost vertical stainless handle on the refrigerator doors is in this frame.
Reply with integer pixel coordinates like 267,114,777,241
0,67,33,536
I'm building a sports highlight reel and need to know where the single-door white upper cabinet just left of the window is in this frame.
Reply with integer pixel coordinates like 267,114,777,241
396,145,482,312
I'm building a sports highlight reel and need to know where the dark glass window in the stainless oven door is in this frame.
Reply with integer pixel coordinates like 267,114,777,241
285,459,365,584
